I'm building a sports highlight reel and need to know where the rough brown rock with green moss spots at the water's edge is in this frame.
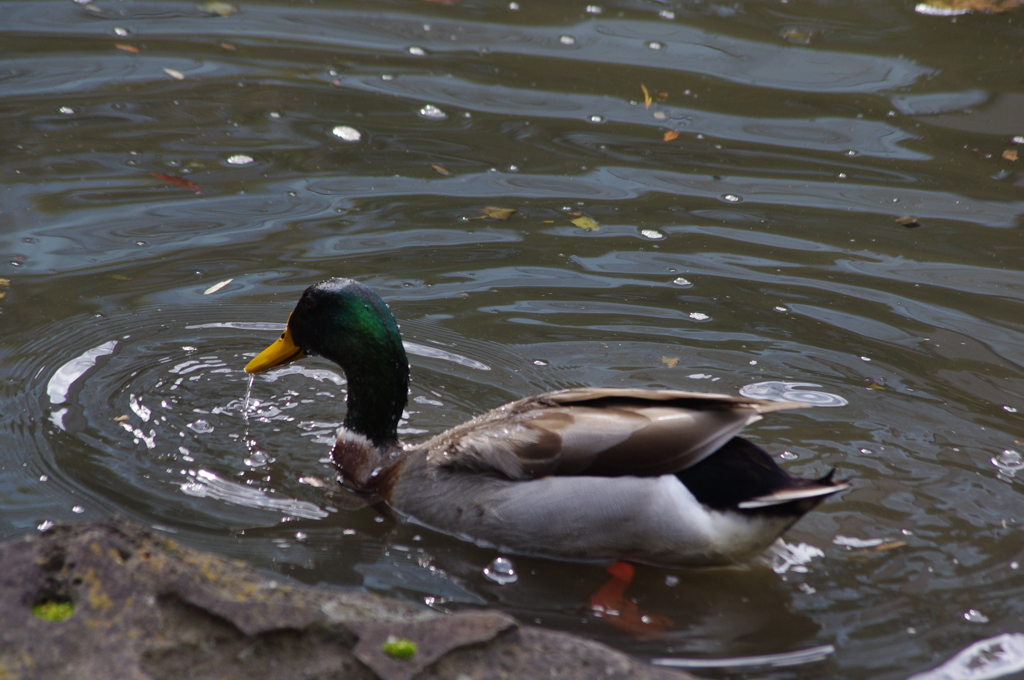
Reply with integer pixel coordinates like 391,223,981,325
0,519,693,680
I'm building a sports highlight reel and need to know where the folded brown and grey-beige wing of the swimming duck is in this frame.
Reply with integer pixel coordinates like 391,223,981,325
424,388,807,479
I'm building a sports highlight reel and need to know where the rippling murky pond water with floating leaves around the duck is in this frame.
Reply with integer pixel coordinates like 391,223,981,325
0,0,1024,679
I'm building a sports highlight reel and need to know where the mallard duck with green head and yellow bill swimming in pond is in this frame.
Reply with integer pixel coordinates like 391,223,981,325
246,279,848,566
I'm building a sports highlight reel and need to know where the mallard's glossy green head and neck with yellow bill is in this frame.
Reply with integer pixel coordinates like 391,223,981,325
246,279,409,445
